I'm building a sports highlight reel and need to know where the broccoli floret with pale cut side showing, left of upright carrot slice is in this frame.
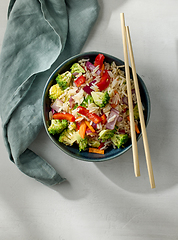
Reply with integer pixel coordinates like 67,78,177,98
58,128,78,146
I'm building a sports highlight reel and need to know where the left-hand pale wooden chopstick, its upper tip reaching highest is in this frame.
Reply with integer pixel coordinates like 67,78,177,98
120,13,140,177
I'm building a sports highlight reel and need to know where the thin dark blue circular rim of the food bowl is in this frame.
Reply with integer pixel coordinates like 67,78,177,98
42,51,151,162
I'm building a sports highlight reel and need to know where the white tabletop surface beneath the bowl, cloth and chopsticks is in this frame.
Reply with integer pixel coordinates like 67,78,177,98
0,0,178,240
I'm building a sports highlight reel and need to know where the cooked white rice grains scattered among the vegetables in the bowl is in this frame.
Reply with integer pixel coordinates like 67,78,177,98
49,54,140,150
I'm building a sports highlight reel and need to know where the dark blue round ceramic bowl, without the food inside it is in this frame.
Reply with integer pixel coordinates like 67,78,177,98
42,52,151,162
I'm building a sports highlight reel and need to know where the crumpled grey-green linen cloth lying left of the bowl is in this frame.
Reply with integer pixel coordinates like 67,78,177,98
0,0,99,186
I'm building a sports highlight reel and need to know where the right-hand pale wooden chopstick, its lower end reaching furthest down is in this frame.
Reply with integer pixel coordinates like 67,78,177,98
126,26,155,188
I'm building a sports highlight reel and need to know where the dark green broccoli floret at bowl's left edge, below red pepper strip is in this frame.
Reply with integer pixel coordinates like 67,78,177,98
48,119,68,135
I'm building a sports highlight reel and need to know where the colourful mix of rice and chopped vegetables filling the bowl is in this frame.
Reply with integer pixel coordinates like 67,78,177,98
48,54,140,154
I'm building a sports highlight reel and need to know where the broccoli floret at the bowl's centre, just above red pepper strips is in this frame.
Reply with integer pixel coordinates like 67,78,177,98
91,91,110,108
